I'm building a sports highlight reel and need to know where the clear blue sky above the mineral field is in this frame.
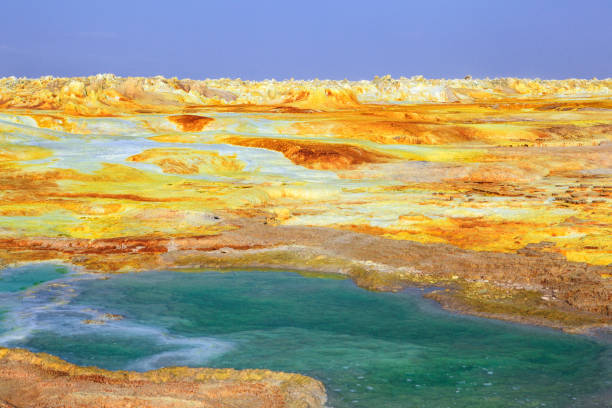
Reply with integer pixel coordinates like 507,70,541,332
0,0,612,79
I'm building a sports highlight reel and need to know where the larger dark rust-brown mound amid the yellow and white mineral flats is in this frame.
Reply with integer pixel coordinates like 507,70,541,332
222,137,397,170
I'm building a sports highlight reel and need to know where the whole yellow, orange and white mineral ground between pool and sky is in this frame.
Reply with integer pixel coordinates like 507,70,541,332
0,74,612,328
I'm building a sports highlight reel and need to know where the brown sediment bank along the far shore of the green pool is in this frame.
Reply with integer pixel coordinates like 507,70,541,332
0,217,612,328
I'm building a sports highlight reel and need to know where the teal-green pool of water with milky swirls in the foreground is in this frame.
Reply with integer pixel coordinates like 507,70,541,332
0,265,612,407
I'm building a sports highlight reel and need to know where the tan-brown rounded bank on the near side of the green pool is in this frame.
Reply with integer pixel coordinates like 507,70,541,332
0,348,327,408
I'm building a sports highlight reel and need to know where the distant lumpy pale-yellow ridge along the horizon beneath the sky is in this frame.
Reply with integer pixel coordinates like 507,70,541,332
0,74,612,116
